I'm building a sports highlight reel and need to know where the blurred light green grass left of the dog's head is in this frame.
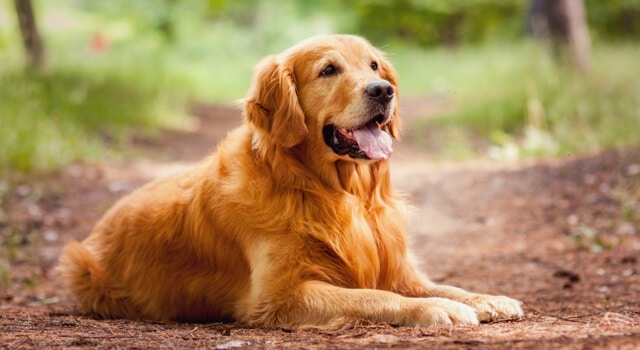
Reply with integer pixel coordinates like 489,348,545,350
0,0,344,172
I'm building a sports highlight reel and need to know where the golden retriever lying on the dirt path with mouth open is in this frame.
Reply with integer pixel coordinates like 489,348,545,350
58,35,523,328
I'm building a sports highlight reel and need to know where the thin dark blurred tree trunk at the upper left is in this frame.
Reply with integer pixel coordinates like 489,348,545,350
15,0,44,68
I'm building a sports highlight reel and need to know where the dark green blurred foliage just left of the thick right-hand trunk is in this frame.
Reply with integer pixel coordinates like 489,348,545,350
354,0,526,45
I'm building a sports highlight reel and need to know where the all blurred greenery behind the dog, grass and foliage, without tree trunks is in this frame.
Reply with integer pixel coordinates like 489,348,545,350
0,0,640,171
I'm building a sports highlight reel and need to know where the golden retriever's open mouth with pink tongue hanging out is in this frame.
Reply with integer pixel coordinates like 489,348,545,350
322,115,393,160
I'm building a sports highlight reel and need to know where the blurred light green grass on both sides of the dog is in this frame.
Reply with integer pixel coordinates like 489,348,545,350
0,0,640,172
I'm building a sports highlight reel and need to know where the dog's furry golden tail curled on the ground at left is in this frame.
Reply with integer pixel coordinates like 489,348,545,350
56,241,133,318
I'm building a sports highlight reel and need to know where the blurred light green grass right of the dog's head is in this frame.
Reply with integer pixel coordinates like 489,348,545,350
388,43,640,158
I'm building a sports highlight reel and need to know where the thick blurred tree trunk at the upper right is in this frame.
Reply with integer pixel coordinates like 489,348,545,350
529,0,591,72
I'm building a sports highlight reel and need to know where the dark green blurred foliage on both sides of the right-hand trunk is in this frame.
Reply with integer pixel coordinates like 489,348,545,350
352,0,640,46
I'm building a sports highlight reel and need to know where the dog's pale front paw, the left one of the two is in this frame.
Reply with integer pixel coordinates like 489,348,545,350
409,298,479,327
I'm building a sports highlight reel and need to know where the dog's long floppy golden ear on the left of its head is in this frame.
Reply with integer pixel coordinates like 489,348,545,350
245,56,309,148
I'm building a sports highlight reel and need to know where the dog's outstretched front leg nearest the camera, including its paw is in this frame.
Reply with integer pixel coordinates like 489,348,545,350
242,281,478,327
